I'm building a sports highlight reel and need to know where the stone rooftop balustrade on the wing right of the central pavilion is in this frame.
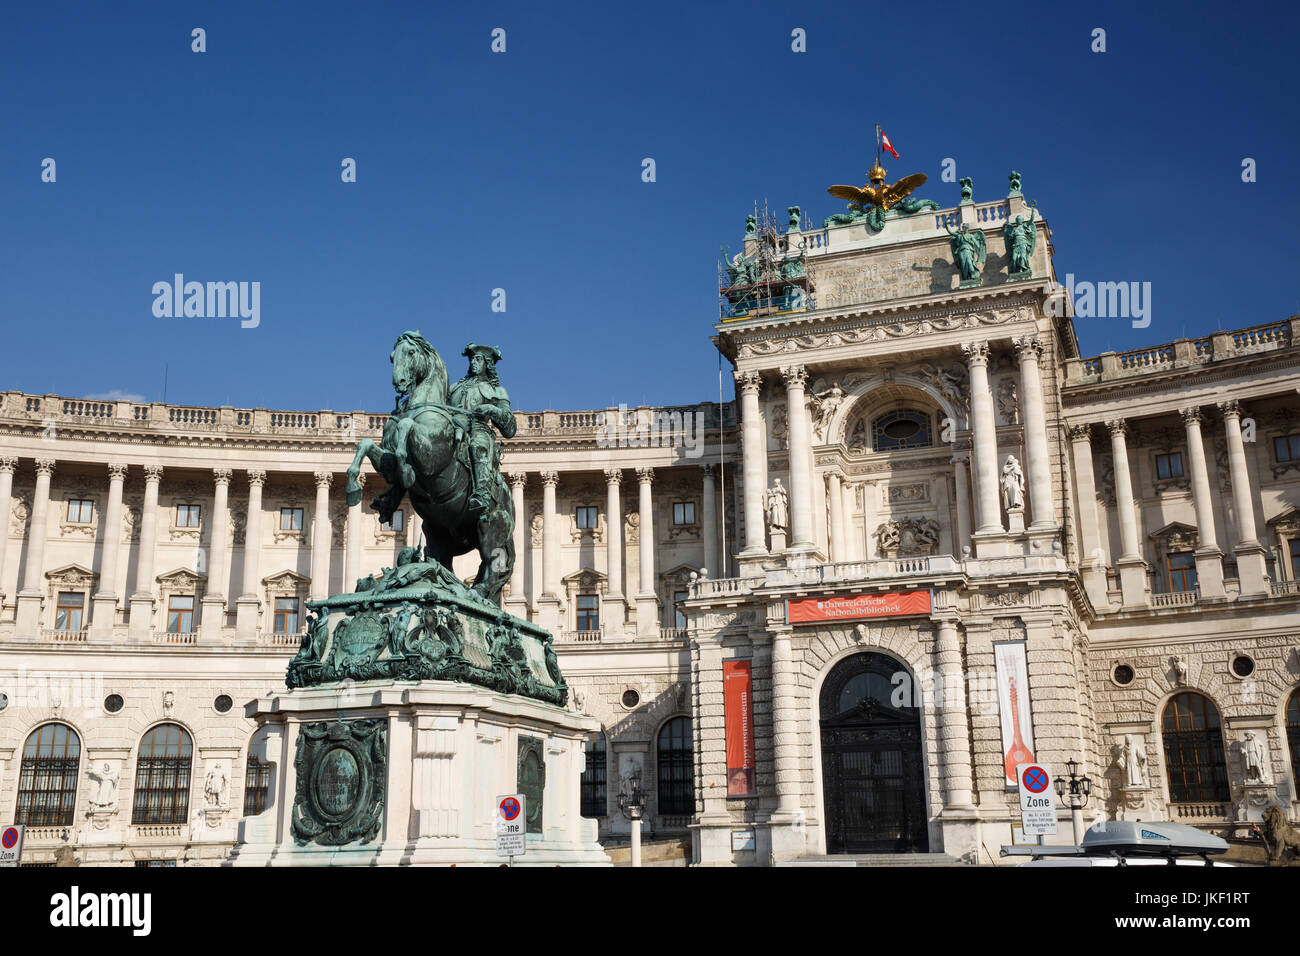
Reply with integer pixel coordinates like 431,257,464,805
1065,315,1300,386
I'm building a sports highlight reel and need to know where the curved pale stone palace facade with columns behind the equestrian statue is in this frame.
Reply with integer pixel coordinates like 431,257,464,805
0,170,1300,865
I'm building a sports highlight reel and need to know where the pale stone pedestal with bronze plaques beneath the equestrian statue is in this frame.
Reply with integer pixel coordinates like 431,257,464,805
226,680,608,866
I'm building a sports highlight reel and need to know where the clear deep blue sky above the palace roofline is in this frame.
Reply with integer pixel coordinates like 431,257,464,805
0,0,1300,410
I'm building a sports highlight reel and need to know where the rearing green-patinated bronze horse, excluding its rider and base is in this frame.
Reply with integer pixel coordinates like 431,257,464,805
347,332,515,604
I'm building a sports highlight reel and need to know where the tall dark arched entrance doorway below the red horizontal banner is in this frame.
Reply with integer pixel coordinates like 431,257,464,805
819,653,930,853
